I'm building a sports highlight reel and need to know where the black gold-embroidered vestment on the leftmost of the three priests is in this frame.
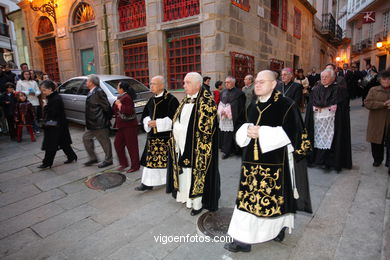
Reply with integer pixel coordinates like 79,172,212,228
141,90,179,169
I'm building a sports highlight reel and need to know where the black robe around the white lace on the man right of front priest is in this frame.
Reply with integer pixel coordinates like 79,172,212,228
305,83,352,171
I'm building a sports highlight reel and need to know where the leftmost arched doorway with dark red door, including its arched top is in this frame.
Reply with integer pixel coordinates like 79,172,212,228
38,16,60,82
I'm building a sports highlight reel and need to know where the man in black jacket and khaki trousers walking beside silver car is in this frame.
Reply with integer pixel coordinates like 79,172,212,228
83,74,112,168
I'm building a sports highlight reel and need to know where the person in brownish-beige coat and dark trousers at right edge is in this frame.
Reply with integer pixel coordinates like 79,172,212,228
364,70,390,167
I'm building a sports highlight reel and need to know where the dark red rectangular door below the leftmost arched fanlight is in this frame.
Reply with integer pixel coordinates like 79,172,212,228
41,39,60,82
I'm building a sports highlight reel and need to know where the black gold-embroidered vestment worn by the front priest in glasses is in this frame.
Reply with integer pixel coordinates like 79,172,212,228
236,91,312,217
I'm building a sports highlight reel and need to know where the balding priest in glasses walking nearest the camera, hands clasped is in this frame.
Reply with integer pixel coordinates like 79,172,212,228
225,70,311,252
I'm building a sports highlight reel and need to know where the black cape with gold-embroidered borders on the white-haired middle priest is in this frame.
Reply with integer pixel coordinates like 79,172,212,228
166,88,221,211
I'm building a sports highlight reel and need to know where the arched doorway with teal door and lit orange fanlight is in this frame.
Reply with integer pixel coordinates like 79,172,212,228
71,2,99,75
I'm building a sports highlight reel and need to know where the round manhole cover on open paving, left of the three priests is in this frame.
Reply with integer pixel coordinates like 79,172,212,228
85,172,126,190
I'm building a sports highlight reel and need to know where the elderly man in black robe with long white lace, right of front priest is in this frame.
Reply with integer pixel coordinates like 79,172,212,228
305,69,352,172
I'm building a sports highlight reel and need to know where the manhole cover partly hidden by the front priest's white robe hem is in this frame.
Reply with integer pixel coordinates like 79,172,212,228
198,208,233,238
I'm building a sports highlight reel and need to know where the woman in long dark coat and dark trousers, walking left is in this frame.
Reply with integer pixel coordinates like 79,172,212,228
38,80,77,169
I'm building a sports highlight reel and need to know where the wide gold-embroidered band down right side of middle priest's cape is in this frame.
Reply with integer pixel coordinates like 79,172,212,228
191,91,217,197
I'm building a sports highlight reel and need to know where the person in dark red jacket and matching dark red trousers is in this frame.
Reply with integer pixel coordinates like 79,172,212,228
112,81,140,173
